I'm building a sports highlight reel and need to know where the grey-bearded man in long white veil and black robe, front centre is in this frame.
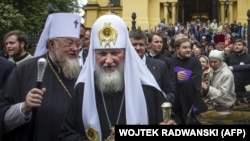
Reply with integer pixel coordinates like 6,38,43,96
59,14,166,141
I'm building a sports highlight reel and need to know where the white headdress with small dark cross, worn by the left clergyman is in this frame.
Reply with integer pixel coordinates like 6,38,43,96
34,13,81,56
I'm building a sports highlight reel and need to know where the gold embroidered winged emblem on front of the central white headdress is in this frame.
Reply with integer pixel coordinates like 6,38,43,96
98,23,118,48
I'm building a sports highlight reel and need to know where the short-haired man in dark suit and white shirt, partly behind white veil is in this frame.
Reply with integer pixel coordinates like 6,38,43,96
129,30,175,103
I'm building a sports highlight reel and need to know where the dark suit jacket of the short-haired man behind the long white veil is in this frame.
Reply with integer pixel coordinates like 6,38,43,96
146,57,175,102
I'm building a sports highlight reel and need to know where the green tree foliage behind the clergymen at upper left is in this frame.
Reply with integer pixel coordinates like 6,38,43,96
0,0,80,49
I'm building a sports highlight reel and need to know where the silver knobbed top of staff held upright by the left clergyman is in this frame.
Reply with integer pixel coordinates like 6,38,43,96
36,58,47,89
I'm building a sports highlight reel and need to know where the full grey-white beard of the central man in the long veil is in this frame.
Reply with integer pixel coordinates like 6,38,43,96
95,62,124,93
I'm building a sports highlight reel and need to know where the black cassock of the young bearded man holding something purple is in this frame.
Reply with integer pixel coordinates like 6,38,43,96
172,55,207,124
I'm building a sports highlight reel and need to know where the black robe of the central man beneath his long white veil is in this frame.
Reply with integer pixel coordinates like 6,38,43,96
59,83,166,141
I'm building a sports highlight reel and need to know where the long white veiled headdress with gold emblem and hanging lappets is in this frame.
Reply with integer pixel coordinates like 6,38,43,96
76,14,161,140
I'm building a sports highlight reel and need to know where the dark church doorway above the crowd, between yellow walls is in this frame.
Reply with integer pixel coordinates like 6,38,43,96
178,0,219,24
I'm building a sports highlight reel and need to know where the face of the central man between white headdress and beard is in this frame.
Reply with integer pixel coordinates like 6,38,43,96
95,49,125,72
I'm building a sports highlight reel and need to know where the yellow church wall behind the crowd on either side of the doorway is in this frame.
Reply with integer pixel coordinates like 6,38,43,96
84,0,250,30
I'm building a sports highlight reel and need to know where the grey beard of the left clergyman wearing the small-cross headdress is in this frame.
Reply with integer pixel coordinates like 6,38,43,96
55,47,81,79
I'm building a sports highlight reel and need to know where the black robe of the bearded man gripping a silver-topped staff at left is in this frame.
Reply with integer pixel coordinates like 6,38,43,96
0,53,75,141
